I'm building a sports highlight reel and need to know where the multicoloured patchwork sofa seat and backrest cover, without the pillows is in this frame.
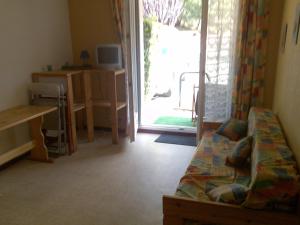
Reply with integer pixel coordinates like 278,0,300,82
176,108,299,211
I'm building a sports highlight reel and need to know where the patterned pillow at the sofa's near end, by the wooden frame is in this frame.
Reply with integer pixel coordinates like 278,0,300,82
207,183,249,205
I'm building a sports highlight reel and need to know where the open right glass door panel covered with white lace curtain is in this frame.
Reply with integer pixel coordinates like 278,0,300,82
198,0,240,141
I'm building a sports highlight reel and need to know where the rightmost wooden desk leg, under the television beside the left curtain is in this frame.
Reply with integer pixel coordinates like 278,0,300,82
110,73,119,144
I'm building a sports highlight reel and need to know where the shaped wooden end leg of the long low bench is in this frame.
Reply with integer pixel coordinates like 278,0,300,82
29,116,51,162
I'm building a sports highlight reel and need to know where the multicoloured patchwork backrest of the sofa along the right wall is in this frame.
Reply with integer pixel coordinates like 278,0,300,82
243,108,299,210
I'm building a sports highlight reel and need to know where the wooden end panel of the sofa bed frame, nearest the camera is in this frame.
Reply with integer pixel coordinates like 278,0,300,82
163,196,300,225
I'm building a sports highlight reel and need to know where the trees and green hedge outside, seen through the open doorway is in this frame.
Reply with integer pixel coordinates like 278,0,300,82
143,0,201,96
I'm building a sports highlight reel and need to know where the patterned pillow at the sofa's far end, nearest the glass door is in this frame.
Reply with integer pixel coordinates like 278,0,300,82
217,119,248,141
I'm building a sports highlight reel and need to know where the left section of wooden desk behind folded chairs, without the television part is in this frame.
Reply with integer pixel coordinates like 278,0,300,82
32,70,94,154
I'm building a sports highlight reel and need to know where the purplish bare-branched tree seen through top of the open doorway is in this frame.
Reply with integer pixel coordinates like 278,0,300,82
143,0,184,26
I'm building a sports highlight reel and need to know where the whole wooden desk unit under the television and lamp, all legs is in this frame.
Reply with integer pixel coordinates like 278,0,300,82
32,69,128,146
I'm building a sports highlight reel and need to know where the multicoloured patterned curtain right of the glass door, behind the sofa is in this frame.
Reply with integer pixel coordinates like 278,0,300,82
232,0,269,120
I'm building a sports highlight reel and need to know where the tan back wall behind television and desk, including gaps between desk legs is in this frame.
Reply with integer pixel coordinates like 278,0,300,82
69,0,126,128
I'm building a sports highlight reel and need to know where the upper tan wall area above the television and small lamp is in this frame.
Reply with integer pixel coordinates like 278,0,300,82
69,0,118,65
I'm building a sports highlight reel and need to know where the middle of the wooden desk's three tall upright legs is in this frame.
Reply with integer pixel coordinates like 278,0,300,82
83,72,94,142
